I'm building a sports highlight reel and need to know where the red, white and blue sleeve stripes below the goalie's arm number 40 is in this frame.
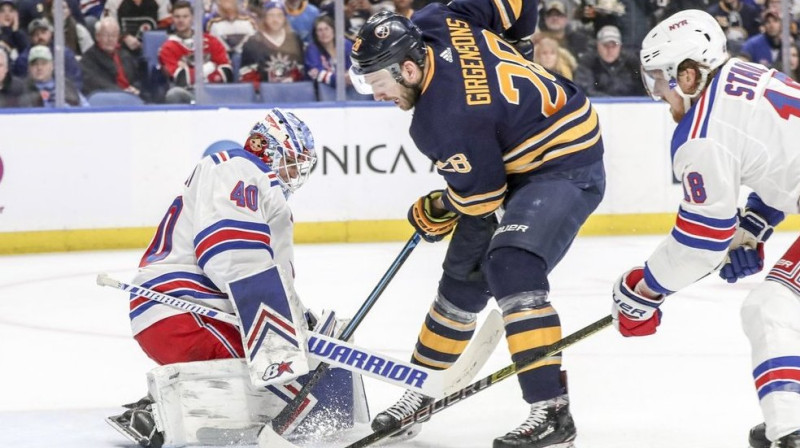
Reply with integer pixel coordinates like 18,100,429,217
194,219,274,269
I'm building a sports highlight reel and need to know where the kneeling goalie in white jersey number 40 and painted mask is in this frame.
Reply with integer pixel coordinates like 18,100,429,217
104,108,370,447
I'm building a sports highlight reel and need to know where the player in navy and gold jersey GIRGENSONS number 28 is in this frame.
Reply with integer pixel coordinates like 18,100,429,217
350,0,605,448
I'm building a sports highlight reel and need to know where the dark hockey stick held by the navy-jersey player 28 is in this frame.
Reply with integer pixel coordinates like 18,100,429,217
272,232,421,434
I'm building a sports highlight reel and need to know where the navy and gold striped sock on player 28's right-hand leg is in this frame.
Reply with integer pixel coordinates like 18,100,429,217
497,291,564,403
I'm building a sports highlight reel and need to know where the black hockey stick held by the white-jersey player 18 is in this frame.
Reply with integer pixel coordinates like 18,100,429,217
345,315,611,448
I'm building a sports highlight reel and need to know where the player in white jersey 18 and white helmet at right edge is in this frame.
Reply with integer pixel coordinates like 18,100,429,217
612,10,800,448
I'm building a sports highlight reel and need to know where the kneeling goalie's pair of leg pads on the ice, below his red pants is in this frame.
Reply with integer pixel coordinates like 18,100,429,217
147,359,368,446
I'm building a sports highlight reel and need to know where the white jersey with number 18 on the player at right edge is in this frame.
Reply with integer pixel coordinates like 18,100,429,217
645,59,800,294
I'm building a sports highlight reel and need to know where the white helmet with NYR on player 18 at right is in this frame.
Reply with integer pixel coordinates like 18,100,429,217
639,9,728,100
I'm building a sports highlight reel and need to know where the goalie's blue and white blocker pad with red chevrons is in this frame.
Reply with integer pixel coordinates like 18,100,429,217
228,266,309,386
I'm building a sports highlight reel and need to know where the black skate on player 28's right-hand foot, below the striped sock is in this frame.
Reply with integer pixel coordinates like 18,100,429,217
493,395,576,448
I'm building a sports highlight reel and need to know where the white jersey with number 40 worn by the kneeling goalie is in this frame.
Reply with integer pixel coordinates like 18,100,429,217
130,150,294,335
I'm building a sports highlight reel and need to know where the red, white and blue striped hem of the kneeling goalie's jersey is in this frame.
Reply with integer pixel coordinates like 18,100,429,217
129,271,228,320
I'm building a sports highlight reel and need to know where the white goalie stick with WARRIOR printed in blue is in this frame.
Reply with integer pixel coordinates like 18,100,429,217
97,274,504,398
